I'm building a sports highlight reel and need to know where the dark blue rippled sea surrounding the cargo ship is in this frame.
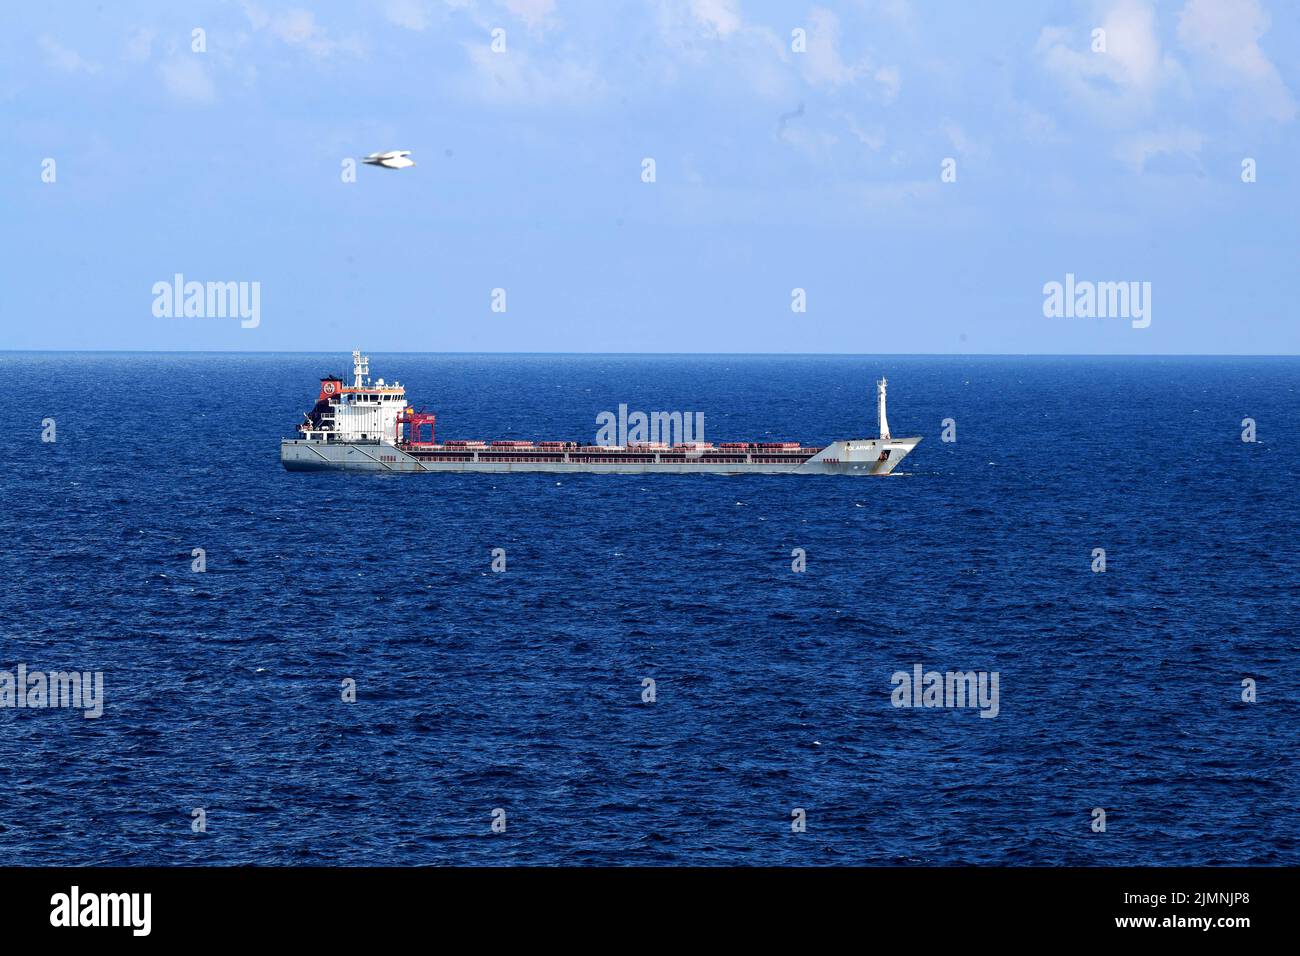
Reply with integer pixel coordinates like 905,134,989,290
0,352,1300,865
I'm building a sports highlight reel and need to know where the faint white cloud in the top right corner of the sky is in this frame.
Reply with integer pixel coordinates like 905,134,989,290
1178,0,1296,122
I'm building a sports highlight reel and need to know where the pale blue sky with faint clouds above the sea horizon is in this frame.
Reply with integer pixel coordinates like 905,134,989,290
0,0,1300,354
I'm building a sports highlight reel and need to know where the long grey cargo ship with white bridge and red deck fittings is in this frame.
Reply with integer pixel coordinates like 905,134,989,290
280,351,920,475
